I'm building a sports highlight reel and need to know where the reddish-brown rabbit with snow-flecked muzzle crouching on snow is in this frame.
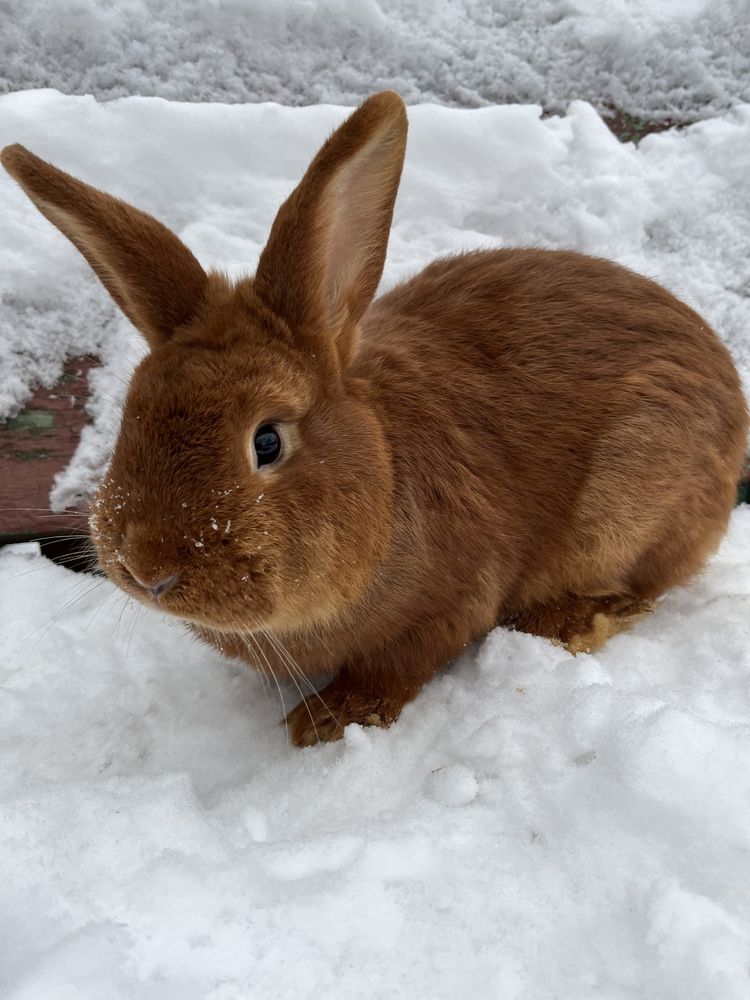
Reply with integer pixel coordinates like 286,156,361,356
2,93,747,745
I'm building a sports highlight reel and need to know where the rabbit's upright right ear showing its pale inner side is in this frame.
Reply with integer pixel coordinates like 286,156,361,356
255,91,407,362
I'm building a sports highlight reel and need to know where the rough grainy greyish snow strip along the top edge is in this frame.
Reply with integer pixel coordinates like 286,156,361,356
0,0,750,121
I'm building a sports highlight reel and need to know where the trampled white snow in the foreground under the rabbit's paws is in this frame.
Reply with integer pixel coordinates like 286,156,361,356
0,508,750,1000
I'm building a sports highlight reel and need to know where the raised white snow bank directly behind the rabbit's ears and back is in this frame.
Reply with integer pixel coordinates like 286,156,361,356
0,90,750,507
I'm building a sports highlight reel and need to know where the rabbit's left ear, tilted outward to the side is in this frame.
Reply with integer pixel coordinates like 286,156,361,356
0,145,207,347
